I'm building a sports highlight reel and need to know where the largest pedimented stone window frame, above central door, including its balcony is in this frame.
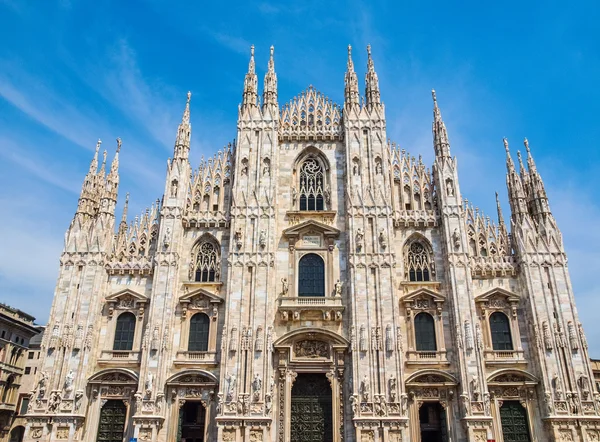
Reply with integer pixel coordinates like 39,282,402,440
278,220,344,322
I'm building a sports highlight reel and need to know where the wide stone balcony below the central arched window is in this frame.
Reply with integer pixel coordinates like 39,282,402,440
278,296,344,322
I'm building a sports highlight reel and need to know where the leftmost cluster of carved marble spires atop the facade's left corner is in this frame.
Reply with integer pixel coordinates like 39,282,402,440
76,138,121,219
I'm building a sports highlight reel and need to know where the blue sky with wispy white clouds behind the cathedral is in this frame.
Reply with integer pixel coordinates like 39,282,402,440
0,0,600,357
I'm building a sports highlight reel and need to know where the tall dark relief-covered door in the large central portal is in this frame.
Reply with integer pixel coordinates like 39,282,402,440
290,373,333,442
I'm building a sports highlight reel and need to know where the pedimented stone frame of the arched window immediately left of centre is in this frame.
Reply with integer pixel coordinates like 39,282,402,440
174,286,223,365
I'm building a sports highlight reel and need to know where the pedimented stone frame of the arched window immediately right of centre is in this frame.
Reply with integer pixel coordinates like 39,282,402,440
401,288,448,365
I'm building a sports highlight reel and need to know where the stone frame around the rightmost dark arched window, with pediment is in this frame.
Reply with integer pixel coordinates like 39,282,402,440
475,287,527,365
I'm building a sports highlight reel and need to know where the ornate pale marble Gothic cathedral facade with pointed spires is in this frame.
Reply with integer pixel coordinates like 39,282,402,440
24,48,600,442
